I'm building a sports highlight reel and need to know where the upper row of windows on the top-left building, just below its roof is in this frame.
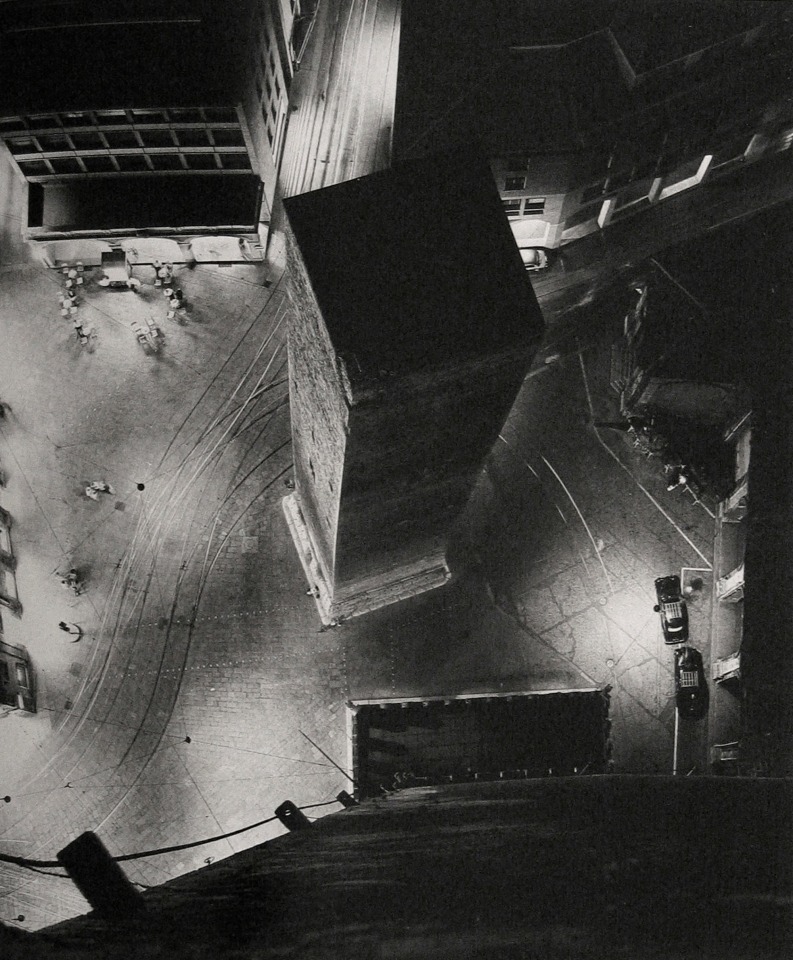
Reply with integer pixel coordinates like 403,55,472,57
5,127,245,155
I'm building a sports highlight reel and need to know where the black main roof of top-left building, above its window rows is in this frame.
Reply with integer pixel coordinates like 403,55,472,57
0,0,251,115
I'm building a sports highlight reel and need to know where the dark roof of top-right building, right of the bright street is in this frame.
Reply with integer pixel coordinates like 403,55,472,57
394,0,789,158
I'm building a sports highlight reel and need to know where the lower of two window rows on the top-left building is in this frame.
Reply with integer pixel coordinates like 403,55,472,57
18,151,251,177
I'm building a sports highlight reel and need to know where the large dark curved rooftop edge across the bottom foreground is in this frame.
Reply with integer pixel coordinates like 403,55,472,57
10,775,793,960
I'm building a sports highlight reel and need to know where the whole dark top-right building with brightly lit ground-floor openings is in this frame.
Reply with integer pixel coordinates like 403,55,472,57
395,0,793,265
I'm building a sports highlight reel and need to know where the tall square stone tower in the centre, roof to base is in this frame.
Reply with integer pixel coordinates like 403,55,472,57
284,152,543,622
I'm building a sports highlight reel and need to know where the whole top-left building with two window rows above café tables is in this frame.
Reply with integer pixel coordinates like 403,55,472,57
0,0,310,262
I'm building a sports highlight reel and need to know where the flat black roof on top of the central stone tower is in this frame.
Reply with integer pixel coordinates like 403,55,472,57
284,149,543,381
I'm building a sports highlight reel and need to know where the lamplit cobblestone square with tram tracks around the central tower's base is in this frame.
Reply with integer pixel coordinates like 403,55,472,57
0,180,710,927
